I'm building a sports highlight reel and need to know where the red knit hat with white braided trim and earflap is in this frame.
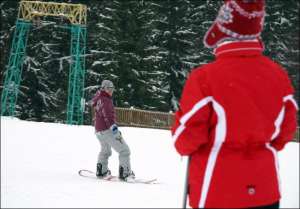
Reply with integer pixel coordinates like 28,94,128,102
203,0,265,48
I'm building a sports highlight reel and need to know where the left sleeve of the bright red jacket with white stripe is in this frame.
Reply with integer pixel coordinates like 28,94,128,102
171,69,212,155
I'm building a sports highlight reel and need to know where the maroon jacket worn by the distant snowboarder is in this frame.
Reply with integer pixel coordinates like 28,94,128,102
92,91,116,132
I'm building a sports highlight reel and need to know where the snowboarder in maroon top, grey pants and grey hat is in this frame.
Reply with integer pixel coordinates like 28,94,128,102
91,80,135,181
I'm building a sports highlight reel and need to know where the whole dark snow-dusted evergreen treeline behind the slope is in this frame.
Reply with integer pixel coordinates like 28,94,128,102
0,0,300,123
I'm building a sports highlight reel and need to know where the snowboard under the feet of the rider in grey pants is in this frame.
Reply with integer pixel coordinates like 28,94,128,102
78,169,158,184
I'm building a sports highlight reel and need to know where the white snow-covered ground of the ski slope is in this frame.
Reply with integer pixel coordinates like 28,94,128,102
1,117,299,208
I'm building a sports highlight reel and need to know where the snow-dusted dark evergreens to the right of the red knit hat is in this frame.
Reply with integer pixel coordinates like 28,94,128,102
262,0,300,103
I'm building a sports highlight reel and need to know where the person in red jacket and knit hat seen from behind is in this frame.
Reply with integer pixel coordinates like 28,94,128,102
172,0,298,208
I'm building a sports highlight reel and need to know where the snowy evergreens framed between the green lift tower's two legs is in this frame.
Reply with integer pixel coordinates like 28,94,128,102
17,18,70,121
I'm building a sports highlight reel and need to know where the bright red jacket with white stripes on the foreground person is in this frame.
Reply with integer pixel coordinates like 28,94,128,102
175,42,296,207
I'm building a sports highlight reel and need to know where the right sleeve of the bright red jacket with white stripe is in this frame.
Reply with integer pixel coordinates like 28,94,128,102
271,70,298,151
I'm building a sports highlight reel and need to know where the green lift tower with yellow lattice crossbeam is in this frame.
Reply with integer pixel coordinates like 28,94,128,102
1,1,87,124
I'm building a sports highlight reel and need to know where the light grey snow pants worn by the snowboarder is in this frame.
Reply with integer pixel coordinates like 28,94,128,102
96,129,131,173
